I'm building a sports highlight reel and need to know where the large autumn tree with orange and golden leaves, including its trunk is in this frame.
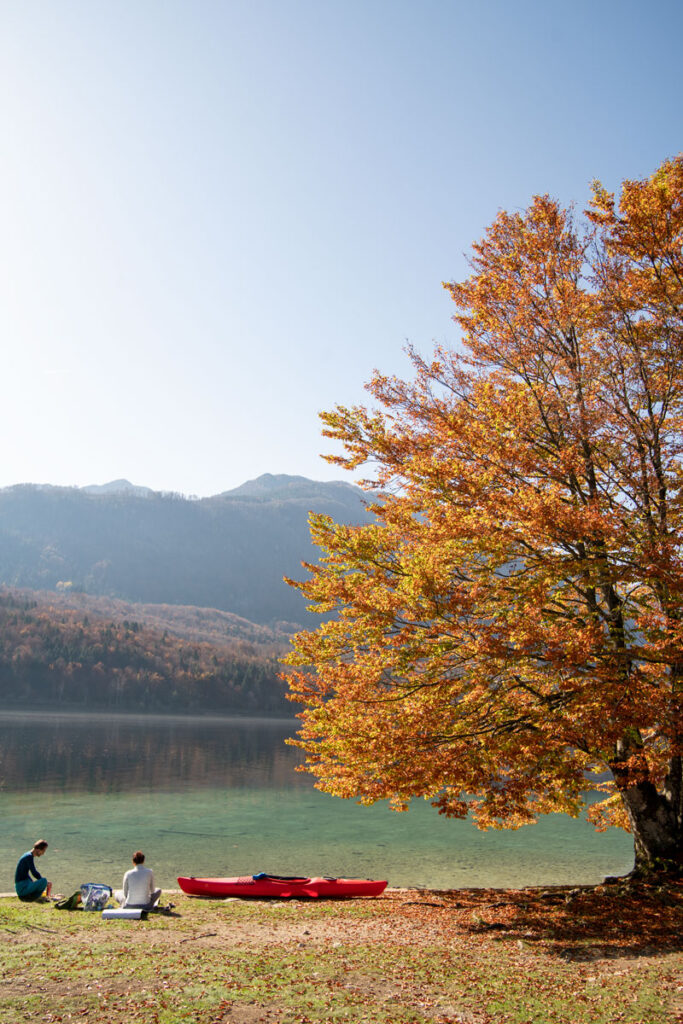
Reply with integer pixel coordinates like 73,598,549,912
290,157,683,870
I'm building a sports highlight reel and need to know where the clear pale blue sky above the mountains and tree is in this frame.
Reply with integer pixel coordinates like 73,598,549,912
0,0,683,496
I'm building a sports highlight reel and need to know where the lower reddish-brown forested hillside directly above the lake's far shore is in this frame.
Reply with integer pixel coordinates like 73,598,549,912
0,592,292,716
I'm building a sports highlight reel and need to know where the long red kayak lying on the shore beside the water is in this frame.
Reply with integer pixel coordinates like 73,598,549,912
178,873,386,899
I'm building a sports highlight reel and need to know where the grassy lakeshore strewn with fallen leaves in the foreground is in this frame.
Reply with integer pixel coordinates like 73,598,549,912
0,897,683,1024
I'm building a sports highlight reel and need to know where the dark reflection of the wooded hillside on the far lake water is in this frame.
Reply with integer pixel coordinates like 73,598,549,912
0,717,310,794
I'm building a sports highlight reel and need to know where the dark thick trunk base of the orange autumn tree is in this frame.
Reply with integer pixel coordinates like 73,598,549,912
611,755,683,874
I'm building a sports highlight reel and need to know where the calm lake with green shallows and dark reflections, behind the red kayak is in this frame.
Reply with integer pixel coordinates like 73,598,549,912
0,713,633,892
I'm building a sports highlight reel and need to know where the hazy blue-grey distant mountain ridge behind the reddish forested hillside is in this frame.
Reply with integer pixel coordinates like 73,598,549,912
0,474,369,624
